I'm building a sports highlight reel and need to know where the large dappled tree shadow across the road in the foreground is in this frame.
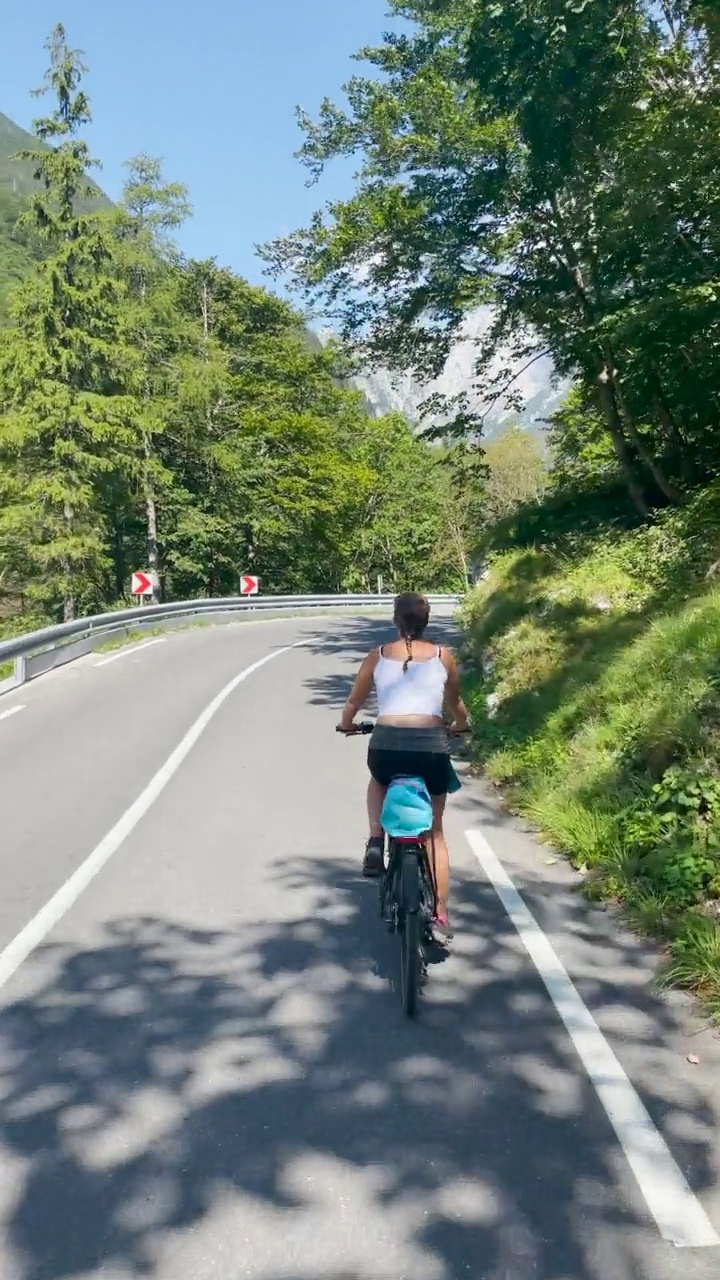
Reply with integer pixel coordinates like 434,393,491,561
0,844,712,1280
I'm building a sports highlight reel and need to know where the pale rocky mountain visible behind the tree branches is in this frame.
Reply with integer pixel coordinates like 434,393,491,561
319,307,569,438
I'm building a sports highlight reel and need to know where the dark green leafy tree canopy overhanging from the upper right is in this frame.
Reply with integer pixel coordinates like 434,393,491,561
266,0,720,515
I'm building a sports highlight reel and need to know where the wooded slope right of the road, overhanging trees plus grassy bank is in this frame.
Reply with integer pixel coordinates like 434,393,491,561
266,0,720,1009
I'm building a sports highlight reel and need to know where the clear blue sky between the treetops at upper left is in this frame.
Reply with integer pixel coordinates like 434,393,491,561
0,0,389,283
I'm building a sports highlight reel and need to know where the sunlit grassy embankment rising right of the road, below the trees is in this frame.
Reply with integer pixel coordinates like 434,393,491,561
465,486,720,1015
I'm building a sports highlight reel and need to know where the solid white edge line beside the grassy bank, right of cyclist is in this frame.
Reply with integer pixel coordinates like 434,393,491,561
465,829,720,1248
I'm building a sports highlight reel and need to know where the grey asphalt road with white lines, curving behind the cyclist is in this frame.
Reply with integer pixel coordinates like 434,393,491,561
0,620,720,1280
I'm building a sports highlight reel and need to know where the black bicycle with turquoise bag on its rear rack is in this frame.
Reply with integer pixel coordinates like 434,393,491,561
338,721,437,1018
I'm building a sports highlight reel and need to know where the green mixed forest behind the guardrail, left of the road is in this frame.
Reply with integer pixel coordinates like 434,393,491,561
0,28,491,630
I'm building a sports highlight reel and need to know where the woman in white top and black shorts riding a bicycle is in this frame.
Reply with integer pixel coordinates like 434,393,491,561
338,591,468,937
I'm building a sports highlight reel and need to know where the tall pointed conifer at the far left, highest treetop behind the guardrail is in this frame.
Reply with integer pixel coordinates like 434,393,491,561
0,26,137,620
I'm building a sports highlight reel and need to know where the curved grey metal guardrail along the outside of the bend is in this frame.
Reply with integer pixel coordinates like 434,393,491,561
0,594,461,694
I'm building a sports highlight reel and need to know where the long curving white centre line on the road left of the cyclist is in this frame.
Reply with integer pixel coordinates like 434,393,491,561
0,640,307,987
